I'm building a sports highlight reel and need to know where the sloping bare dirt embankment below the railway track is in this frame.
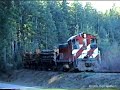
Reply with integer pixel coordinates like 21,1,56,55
0,69,120,89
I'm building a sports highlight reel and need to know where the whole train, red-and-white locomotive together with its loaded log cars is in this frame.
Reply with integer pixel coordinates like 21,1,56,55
23,33,101,71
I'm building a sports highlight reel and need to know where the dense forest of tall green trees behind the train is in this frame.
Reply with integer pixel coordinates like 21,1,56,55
0,0,120,70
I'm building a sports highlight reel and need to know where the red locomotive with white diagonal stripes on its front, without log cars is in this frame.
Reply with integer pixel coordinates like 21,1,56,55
56,33,101,71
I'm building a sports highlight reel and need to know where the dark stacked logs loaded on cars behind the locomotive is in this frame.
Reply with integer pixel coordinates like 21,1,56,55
23,50,56,70
